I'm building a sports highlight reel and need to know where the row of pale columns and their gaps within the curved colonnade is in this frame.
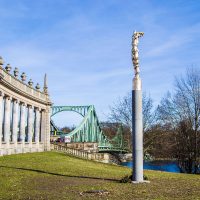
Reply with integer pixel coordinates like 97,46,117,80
0,92,44,148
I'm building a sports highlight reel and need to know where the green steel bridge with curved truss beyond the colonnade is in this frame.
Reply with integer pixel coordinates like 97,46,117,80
51,105,127,152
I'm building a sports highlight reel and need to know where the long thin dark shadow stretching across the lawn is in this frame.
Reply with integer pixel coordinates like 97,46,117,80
0,165,120,183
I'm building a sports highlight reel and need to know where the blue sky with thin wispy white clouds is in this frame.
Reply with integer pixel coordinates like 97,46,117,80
0,0,200,126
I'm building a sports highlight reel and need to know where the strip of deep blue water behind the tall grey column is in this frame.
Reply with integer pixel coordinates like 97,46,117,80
122,160,180,173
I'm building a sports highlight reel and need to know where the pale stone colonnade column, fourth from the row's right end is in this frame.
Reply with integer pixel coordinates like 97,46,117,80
12,100,19,148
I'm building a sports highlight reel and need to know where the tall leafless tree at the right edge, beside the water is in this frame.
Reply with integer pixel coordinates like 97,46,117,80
158,69,200,173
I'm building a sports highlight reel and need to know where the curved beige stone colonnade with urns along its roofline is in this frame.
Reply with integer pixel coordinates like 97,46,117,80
0,57,51,155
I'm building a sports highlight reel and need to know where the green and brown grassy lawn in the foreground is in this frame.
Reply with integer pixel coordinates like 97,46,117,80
0,152,200,200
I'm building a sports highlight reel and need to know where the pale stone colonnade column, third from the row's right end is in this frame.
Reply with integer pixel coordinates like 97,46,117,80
19,103,26,145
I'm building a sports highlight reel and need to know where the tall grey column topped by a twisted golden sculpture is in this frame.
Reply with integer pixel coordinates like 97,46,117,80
132,31,144,183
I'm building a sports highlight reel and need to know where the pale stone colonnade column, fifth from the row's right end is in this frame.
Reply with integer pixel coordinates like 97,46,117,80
3,96,11,149
